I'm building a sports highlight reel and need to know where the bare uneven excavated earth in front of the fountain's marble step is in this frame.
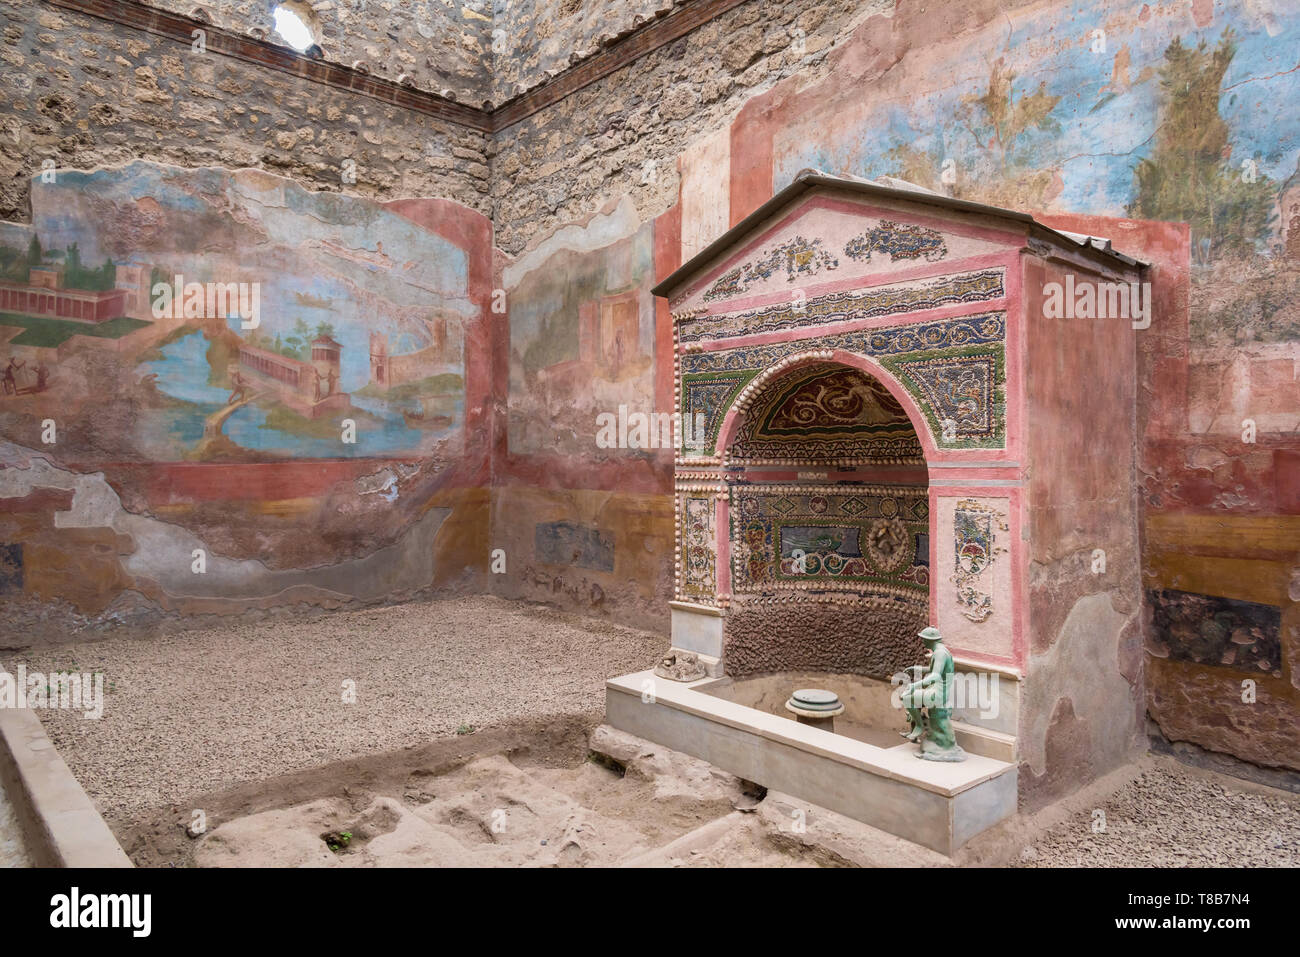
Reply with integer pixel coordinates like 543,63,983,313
189,726,925,867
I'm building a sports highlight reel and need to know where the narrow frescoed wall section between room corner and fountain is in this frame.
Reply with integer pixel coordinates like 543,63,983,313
491,203,672,627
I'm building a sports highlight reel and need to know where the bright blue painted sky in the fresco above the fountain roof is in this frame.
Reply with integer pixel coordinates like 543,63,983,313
776,0,1300,216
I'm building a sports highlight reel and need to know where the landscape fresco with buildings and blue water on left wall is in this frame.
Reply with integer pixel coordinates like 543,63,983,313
0,163,475,462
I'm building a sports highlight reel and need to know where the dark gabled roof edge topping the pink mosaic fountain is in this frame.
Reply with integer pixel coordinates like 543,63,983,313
651,169,1148,296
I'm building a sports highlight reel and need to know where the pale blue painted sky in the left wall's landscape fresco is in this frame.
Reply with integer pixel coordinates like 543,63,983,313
25,163,476,391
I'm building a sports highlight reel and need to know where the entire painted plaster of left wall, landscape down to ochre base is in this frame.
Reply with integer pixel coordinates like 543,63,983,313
0,163,491,631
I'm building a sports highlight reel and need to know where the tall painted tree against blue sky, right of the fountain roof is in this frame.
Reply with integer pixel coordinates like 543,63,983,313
1128,29,1274,265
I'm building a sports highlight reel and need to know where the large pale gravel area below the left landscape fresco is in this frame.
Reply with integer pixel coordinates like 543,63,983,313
5,597,667,817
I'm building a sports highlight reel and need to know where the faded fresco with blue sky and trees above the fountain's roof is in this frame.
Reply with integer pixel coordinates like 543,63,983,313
775,0,1300,347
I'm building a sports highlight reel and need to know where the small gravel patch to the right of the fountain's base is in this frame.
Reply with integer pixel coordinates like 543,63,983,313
1021,757,1300,867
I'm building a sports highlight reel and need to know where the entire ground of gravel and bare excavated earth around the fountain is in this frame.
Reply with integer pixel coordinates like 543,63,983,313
0,597,1300,867
